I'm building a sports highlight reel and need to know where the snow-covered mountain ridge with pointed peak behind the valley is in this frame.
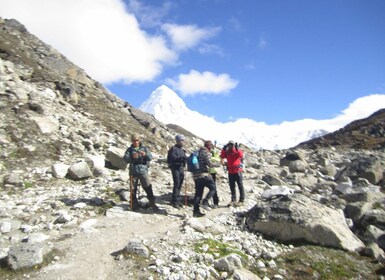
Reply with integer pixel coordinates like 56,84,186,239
139,85,378,150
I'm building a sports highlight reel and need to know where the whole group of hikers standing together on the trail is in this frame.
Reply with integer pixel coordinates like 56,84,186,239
124,134,245,217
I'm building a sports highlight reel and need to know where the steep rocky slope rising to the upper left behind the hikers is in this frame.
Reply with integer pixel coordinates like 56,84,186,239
0,18,188,176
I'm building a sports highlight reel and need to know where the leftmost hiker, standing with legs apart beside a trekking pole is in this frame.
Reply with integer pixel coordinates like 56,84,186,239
124,134,159,211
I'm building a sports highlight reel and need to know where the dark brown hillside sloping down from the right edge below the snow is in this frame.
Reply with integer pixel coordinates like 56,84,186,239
298,109,385,150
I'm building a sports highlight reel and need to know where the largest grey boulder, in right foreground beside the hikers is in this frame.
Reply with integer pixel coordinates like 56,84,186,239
246,194,364,252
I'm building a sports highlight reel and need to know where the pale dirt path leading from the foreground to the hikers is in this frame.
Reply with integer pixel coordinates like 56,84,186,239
29,207,219,280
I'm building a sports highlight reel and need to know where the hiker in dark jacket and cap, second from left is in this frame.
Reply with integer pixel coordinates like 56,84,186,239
167,134,187,209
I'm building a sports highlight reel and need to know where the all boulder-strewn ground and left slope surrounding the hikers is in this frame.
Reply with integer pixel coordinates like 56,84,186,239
0,19,385,280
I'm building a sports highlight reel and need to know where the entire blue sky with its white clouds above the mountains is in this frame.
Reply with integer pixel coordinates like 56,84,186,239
0,0,385,124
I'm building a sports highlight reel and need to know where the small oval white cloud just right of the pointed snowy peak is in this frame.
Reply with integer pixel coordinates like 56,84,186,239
167,70,238,96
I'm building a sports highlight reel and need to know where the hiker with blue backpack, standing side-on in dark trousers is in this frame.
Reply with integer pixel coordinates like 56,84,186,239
193,140,216,217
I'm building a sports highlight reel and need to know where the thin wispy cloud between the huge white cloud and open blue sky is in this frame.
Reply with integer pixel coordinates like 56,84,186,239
162,23,220,51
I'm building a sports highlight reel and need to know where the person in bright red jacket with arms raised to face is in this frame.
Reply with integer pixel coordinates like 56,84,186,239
220,141,245,206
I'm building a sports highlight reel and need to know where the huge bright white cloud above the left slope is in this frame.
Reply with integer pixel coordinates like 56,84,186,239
0,0,177,83
